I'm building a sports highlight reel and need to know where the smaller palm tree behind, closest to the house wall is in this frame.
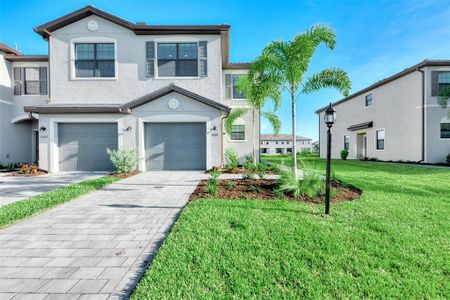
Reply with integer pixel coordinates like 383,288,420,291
225,75,281,163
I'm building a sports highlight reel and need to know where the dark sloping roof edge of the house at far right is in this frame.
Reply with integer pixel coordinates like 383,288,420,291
316,59,450,114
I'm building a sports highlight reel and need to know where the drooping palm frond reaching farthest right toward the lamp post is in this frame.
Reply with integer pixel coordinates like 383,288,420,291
302,68,352,96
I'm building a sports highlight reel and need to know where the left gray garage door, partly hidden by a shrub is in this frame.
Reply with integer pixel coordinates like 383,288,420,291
58,123,117,171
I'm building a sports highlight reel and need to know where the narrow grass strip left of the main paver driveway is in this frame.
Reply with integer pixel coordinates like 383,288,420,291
0,176,120,228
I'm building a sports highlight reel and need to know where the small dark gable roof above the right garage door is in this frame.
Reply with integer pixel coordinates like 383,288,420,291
121,83,230,113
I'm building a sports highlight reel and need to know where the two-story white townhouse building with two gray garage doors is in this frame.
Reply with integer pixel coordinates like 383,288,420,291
0,6,259,172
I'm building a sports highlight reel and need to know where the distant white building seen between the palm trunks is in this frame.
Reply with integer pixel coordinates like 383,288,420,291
260,134,312,154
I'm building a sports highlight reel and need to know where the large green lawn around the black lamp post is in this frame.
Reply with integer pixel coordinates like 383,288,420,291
133,158,450,299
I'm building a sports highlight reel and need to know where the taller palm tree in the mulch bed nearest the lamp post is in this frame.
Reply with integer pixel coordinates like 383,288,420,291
247,25,351,179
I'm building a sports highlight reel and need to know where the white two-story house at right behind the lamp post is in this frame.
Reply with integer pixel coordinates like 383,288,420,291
316,60,450,163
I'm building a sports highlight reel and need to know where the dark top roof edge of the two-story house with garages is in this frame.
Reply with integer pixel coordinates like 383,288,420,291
34,5,246,69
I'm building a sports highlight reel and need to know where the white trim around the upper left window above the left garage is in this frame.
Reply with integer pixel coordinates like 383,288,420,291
70,37,119,81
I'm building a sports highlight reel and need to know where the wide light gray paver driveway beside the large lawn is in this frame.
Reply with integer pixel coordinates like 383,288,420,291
0,172,205,299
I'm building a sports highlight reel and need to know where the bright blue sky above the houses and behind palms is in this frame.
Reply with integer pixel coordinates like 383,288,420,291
0,0,450,139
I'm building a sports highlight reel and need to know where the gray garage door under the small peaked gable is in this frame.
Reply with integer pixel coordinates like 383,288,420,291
145,123,206,170
